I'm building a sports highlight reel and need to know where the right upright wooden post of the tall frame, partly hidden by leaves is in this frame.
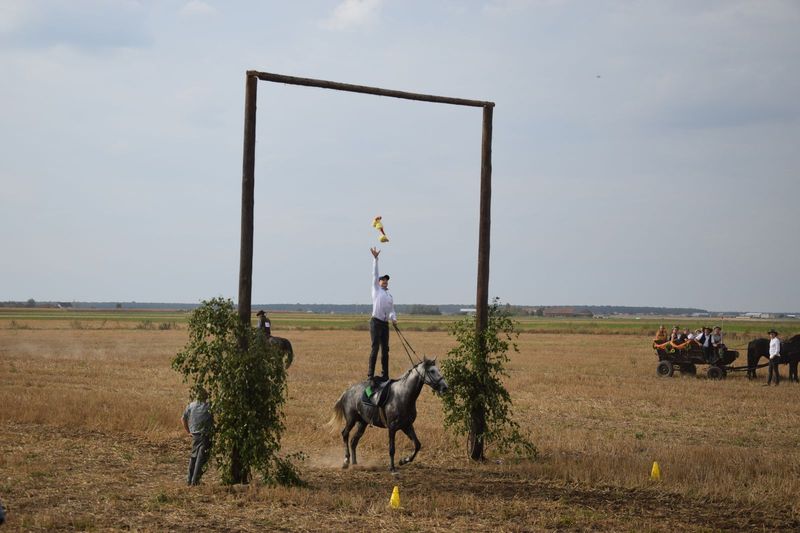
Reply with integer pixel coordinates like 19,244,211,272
468,104,494,461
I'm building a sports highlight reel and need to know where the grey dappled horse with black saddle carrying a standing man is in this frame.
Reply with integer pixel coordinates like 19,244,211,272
330,358,447,472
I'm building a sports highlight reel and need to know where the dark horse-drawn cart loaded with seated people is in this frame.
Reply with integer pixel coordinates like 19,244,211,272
653,341,747,379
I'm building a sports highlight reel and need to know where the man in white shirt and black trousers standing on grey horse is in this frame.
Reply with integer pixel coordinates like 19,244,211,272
367,248,397,382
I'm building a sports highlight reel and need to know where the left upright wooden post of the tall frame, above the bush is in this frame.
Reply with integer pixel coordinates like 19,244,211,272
239,72,258,326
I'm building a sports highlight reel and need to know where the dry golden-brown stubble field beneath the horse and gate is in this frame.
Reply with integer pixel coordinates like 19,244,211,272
0,320,800,531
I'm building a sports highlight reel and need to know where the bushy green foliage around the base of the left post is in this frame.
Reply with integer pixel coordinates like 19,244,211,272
172,298,302,485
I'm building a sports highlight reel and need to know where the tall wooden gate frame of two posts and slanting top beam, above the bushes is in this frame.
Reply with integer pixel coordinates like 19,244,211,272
238,70,494,339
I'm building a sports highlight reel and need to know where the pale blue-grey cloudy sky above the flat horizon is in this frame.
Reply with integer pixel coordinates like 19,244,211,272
0,0,800,312
